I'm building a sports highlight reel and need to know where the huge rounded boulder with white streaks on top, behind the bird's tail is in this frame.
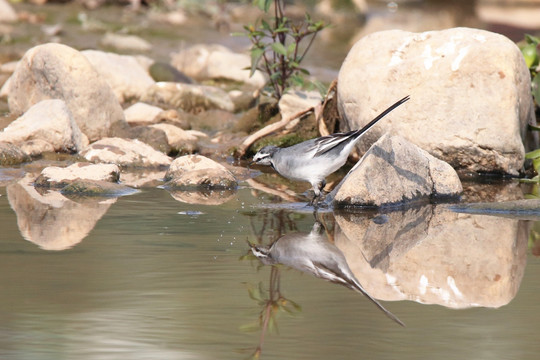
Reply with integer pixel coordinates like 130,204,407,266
338,28,534,174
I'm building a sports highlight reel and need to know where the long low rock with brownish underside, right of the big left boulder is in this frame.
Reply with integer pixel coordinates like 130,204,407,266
141,82,234,112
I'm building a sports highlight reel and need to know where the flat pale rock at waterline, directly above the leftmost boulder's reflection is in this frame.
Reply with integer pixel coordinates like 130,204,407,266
34,163,120,189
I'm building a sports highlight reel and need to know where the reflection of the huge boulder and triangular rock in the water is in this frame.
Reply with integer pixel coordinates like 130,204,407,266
334,206,528,308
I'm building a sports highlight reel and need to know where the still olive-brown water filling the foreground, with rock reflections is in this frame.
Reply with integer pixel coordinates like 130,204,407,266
0,172,540,360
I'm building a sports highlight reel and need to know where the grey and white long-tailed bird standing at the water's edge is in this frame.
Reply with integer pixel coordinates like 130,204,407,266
251,96,409,205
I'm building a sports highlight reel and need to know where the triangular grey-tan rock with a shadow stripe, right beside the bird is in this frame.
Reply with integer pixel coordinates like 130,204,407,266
334,134,463,207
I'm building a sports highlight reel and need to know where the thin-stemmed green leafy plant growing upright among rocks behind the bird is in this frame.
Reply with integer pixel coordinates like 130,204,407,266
242,0,327,100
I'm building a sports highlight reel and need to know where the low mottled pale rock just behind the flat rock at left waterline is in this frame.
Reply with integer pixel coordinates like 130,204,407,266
80,138,171,167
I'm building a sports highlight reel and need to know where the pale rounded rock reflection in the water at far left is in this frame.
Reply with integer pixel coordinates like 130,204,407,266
7,175,116,250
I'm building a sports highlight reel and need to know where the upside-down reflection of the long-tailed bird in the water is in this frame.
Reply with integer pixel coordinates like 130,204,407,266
250,221,405,326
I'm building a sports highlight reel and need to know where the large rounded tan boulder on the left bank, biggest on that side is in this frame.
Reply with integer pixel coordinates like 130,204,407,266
8,43,124,141
